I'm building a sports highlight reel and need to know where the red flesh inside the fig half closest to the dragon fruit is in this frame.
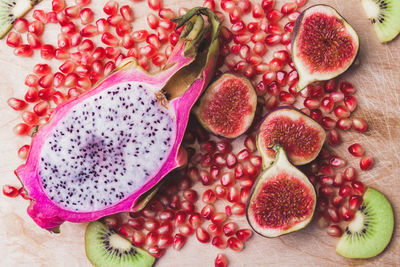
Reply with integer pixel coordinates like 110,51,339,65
202,79,253,136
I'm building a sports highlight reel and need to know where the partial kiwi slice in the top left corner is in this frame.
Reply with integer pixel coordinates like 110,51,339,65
0,0,40,38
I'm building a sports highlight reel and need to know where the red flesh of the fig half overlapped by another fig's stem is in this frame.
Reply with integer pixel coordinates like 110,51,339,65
260,115,320,158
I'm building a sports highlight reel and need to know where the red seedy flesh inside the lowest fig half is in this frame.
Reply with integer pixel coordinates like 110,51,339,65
250,172,314,230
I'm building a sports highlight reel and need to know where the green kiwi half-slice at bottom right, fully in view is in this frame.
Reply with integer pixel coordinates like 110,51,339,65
336,188,394,259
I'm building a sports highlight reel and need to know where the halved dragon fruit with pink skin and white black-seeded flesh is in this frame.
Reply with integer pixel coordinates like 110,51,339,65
15,8,220,231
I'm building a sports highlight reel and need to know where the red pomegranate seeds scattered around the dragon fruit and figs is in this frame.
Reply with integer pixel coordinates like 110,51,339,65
3,0,374,266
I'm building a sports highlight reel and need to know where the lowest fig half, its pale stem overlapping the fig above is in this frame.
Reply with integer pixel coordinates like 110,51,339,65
246,145,316,237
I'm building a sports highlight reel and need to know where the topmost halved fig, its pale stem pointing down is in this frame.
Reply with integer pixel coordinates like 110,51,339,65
292,5,359,91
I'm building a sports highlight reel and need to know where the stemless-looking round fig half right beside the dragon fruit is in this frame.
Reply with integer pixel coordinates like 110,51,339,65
194,73,257,138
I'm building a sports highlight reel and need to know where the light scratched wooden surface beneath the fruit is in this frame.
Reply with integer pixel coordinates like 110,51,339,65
0,0,400,267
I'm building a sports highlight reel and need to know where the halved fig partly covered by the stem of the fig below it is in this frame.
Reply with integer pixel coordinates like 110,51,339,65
257,107,326,168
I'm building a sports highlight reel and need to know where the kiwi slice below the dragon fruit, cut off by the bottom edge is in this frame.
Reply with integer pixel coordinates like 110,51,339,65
85,221,155,267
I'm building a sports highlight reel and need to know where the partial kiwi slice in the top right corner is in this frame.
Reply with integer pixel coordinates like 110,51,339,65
361,0,400,43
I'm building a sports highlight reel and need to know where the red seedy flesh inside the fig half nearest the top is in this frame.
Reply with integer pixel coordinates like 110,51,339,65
297,13,357,73
